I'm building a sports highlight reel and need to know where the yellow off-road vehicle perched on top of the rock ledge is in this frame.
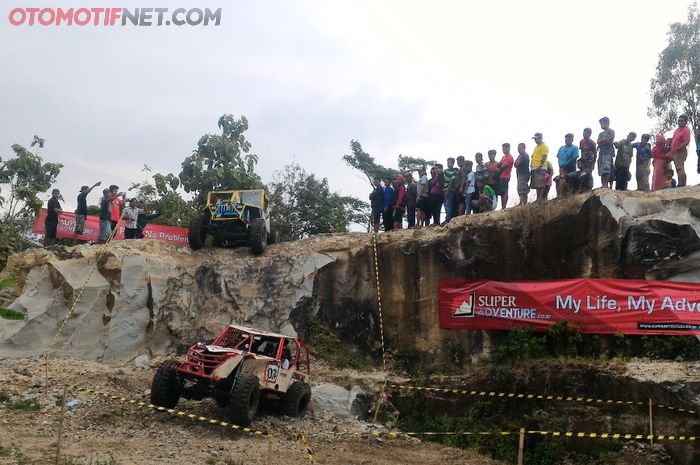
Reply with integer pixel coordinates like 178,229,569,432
188,189,279,255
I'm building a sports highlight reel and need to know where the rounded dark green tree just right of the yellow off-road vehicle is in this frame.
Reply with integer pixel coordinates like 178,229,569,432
269,164,369,240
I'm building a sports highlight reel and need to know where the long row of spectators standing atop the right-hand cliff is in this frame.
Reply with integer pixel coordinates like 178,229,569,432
369,115,700,232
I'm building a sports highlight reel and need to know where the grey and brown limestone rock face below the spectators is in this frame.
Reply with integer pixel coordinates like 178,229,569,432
0,187,700,363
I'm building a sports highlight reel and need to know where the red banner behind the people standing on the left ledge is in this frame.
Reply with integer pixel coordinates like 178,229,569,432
32,208,189,245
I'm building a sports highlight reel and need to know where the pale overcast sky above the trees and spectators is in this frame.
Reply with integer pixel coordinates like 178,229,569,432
0,0,699,212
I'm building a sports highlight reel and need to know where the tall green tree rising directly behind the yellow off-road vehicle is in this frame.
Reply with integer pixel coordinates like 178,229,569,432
179,115,262,205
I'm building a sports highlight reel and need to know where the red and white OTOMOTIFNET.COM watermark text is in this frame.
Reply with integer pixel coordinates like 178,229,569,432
8,7,221,27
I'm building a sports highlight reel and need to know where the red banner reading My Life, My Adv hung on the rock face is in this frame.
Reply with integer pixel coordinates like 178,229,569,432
438,279,700,335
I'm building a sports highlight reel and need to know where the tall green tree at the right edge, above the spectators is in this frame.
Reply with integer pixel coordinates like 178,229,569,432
649,3,700,130
